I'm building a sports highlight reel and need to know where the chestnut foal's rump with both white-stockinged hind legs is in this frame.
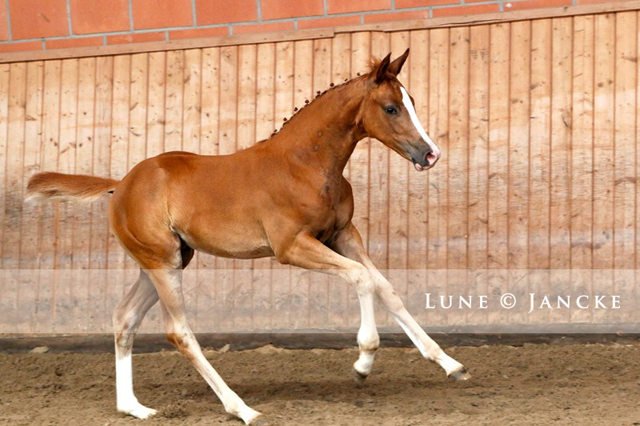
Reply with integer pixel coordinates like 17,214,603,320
109,153,268,424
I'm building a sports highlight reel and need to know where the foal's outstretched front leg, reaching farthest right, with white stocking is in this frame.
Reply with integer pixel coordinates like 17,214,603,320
332,223,471,380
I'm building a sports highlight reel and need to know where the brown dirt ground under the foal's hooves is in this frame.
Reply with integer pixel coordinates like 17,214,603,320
0,343,640,426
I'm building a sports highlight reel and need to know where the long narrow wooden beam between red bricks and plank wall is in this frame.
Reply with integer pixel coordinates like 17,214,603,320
0,0,640,63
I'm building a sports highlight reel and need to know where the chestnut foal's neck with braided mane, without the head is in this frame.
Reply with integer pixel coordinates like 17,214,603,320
269,78,366,179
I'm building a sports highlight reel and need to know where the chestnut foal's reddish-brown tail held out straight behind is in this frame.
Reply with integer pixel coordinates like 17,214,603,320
27,172,120,201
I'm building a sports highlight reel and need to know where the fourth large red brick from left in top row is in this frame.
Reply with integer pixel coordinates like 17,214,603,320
196,0,258,25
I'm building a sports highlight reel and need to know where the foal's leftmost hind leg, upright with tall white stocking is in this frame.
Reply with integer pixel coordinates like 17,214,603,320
113,271,158,419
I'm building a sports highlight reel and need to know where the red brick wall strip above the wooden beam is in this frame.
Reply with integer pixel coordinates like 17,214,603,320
0,0,606,52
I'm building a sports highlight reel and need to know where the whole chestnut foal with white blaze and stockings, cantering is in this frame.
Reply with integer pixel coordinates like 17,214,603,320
28,49,470,424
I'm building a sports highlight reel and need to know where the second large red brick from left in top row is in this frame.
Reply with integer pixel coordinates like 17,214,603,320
69,0,130,34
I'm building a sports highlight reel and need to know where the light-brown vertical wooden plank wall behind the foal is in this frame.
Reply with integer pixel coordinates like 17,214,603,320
0,11,640,332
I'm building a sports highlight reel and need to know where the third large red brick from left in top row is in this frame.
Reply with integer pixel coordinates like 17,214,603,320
131,0,193,30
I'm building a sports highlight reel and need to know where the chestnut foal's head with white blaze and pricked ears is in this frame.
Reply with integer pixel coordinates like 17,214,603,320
360,49,440,171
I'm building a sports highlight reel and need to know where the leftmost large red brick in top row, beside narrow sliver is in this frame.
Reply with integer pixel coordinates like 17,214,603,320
9,0,69,40
